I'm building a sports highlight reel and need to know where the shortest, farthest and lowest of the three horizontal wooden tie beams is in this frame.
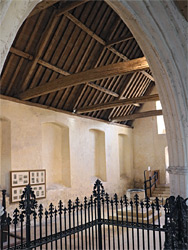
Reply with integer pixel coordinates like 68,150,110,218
111,110,163,122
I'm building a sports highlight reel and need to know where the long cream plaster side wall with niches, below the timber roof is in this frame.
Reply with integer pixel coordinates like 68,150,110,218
0,99,133,209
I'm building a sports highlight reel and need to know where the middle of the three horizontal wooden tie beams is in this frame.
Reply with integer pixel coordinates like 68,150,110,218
76,94,159,114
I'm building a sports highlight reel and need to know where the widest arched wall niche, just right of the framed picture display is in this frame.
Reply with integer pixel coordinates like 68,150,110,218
42,122,71,189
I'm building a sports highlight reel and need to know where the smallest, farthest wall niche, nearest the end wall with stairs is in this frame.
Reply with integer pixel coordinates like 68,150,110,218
118,134,132,179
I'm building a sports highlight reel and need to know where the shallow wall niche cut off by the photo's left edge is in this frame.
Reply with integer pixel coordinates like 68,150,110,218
0,117,11,193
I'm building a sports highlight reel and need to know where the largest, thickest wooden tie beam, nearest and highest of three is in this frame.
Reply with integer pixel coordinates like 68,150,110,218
19,57,149,100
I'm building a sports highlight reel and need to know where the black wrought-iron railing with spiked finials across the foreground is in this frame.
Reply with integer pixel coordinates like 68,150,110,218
1,180,188,250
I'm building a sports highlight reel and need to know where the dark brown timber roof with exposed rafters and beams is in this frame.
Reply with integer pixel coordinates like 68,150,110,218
1,0,159,125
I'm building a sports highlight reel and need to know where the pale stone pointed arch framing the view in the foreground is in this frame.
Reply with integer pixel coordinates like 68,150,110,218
0,0,188,196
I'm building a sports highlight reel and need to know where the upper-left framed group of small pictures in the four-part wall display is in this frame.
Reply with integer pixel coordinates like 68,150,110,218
10,171,29,187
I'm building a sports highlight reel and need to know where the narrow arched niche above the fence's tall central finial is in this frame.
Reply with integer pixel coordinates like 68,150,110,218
89,129,107,181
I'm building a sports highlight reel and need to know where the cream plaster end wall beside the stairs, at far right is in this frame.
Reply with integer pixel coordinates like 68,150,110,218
133,89,167,188
